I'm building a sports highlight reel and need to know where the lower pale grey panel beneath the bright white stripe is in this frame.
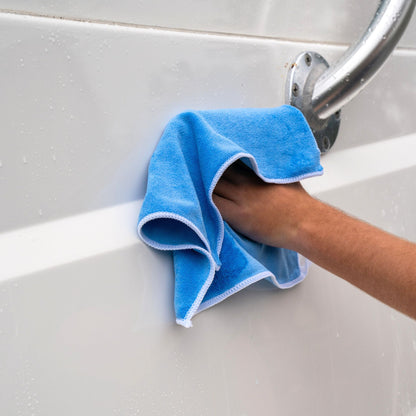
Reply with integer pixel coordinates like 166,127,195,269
0,173,416,416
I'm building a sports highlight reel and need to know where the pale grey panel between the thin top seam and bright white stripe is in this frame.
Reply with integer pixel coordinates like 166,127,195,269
0,14,416,234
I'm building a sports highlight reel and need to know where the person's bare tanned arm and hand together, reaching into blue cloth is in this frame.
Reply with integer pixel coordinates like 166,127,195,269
213,162,416,319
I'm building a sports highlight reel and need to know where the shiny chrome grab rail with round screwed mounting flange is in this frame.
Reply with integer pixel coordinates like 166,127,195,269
286,0,416,153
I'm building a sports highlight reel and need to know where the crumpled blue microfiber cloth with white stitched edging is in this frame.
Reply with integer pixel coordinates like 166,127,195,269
138,105,323,328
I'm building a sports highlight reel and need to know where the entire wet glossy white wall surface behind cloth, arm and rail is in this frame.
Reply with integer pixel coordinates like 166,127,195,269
0,0,416,416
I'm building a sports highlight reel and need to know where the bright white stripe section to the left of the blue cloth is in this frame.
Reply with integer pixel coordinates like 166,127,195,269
0,201,141,282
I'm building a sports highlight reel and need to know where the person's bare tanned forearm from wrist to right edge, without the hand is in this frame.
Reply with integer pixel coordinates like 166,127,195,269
290,197,416,319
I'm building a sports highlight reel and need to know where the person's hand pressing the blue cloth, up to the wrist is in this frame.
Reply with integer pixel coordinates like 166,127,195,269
213,162,317,249
